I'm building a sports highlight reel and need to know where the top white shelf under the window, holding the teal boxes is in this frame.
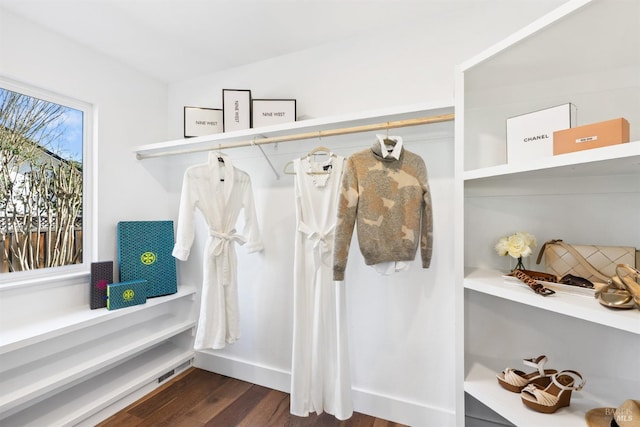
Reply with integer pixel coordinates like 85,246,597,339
0,287,196,355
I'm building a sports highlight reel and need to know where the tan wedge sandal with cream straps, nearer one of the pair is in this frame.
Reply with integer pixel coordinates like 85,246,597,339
520,370,585,414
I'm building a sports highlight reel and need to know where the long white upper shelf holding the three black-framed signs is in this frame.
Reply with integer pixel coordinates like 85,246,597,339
133,100,453,159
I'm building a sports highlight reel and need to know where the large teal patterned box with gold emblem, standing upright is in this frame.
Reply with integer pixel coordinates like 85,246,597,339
118,221,178,298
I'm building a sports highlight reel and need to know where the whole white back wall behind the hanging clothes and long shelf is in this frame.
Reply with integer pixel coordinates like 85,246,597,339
166,1,562,425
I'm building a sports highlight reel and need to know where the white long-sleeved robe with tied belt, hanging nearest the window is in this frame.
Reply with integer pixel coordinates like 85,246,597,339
173,152,262,350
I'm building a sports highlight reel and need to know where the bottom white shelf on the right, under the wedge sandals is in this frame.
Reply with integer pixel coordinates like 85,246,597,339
464,362,638,427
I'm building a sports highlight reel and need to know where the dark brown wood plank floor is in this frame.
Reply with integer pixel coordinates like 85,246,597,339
98,368,403,427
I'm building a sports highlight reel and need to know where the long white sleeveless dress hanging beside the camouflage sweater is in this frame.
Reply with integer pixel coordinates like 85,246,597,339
291,154,353,420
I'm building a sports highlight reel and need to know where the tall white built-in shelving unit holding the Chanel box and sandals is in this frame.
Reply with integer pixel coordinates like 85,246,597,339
455,0,640,427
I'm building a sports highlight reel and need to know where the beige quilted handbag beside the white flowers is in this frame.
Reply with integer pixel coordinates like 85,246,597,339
536,240,636,283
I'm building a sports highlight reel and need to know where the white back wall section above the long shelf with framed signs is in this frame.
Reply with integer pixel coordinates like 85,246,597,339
168,0,567,138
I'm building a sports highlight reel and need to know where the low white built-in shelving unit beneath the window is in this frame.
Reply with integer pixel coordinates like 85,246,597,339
0,287,196,427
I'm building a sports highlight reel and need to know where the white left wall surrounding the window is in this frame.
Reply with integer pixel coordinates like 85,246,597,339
0,9,170,328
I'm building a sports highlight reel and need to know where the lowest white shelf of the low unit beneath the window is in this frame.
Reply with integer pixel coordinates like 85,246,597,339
1,342,193,427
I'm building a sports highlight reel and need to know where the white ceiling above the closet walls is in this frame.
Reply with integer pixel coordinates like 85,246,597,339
0,0,564,83
